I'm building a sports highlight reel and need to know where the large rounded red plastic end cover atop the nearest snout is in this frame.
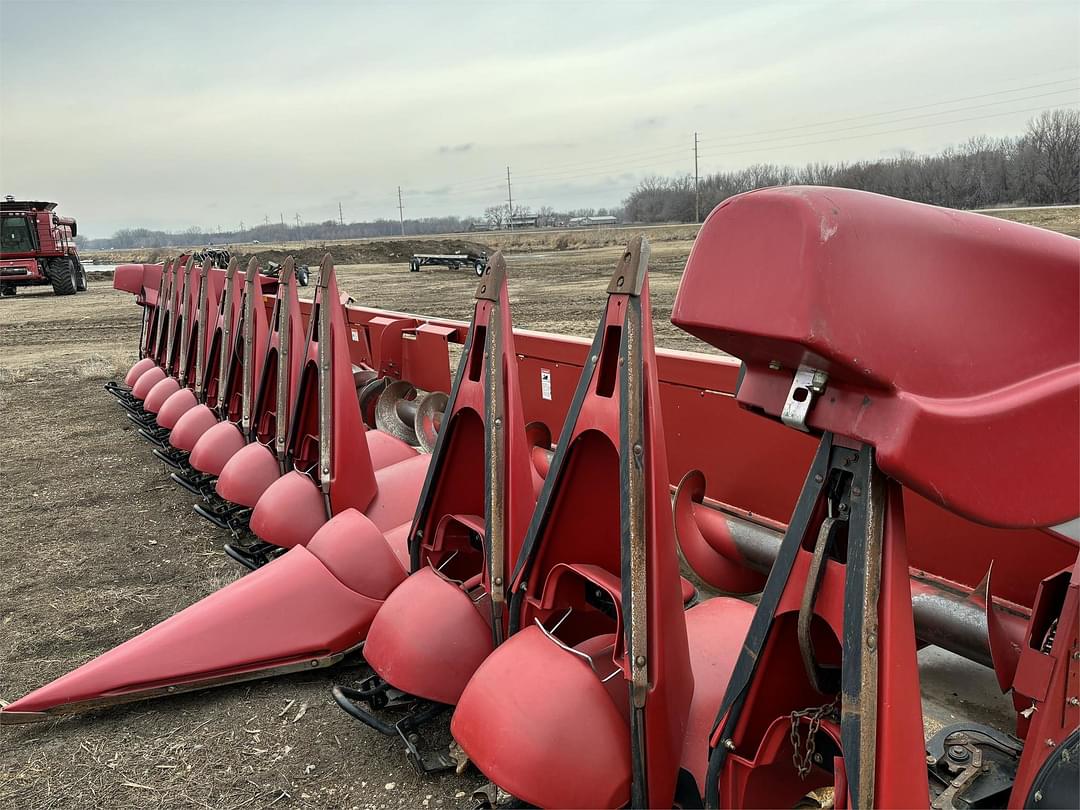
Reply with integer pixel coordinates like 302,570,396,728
673,187,1080,527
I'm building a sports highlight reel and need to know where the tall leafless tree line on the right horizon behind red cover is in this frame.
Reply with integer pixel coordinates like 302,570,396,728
623,109,1080,222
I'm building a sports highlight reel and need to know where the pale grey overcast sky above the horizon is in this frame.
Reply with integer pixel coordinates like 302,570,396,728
0,0,1080,237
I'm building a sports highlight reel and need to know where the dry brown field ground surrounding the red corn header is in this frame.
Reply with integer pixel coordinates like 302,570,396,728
0,216,1078,810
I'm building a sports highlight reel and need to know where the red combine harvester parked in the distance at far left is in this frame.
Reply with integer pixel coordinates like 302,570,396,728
0,194,86,296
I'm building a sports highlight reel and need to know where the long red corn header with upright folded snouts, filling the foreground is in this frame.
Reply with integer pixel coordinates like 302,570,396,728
0,187,1080,808
